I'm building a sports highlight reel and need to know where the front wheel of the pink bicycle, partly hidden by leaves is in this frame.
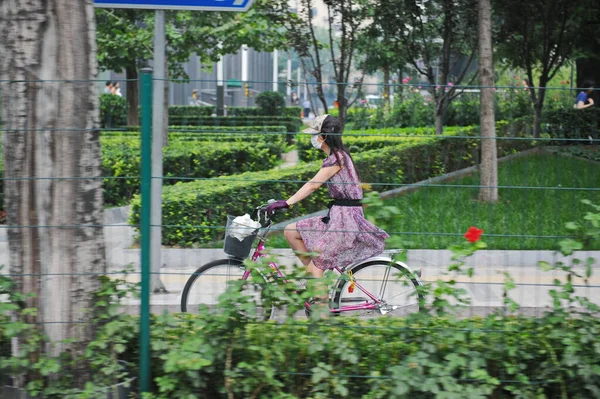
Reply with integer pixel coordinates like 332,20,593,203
181,259,273,320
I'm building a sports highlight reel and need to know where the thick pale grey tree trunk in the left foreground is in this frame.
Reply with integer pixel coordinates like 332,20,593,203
0,0,106,364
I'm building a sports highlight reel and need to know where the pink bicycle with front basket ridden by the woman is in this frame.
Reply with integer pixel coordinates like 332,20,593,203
181,203,424,320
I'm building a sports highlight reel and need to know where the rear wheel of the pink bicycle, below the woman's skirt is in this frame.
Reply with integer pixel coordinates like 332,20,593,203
332,260,424,316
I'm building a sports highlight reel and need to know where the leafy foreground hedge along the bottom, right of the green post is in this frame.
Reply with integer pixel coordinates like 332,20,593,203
144,314,600,399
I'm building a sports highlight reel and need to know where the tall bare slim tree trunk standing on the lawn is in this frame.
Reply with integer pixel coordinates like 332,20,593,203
479,0,498,202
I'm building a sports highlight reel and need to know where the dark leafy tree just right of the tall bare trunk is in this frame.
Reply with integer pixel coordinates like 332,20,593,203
494,0,593,137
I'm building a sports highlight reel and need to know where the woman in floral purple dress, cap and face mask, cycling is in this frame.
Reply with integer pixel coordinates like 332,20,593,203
267,115,389,296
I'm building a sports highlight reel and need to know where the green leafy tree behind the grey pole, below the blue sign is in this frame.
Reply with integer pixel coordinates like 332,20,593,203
96,0,283,125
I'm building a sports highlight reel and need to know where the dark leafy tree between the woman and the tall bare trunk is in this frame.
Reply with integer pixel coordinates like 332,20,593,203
375,0,477,134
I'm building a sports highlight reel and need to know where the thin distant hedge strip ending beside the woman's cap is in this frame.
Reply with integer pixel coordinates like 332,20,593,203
169,115,302,133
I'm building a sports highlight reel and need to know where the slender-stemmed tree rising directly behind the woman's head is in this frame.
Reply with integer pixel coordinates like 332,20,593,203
272,0,372,121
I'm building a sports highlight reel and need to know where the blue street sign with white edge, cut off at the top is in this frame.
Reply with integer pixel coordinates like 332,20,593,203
94,0,254,11
